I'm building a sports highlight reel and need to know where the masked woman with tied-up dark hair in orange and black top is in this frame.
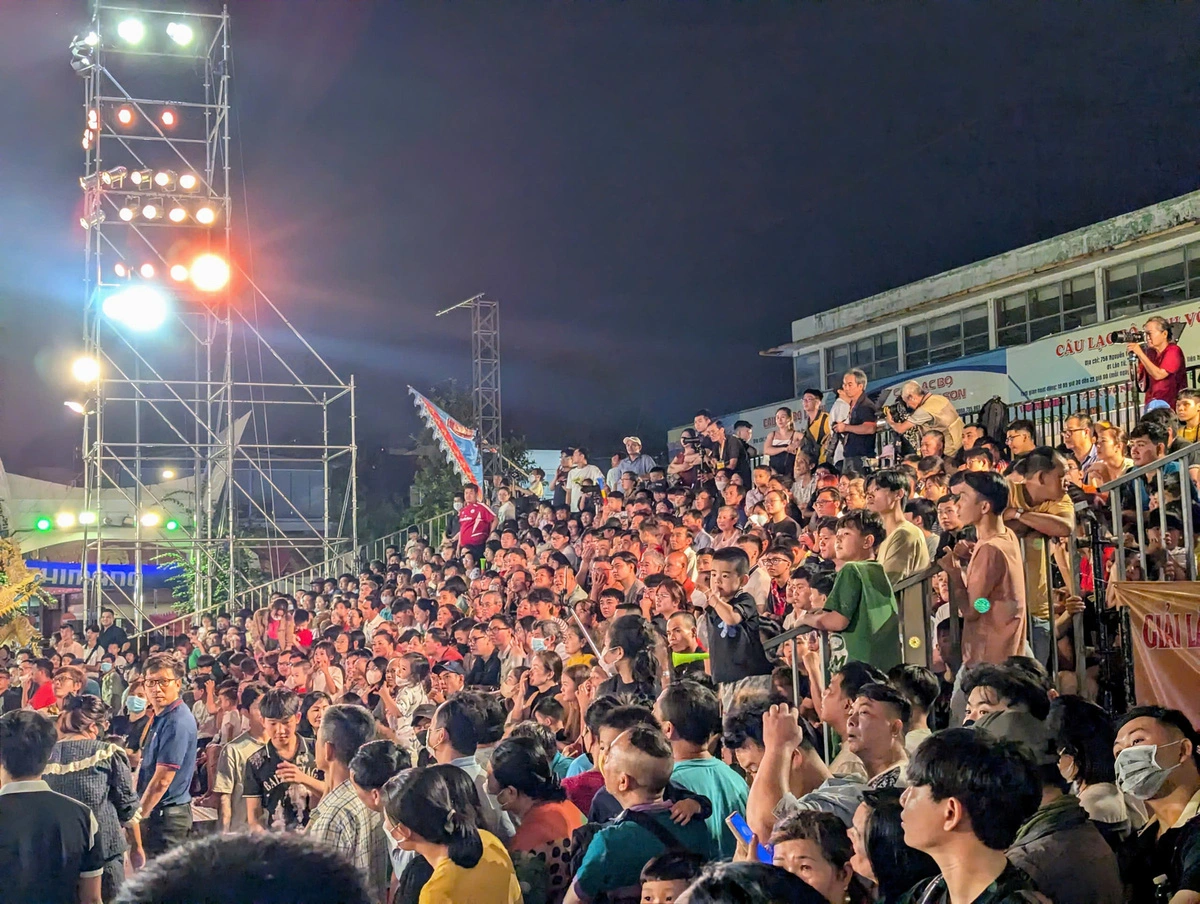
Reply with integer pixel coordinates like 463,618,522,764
487,737,587,900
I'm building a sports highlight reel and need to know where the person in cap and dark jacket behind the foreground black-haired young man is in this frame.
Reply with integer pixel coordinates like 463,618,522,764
976,710,1124,904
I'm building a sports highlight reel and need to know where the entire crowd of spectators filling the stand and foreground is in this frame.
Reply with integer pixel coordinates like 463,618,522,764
0,319,1200,904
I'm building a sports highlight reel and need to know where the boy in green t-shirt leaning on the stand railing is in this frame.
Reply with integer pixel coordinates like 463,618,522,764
797,510,901,672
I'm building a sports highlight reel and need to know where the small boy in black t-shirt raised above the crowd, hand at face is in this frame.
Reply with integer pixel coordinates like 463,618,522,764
704,549,772,708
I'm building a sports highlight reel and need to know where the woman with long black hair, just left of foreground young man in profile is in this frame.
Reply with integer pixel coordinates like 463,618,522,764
850,788,938,904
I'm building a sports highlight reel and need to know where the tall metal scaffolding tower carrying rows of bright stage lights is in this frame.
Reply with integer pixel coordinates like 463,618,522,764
64,0,358,628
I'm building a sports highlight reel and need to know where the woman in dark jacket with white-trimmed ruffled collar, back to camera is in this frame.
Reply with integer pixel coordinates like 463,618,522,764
42,694,140,900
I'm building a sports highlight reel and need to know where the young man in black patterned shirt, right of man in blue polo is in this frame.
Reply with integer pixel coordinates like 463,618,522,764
242,688,324,832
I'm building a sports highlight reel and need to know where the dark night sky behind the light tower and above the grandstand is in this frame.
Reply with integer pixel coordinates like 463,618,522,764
0,0,1200,471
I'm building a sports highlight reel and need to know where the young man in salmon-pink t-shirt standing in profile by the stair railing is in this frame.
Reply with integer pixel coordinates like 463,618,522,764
940,471,1026,725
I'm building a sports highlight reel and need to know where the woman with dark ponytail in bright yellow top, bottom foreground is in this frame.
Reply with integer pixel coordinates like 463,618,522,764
383,766,522,904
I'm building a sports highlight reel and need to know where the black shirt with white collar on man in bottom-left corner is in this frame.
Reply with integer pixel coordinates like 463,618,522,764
0,782,104,904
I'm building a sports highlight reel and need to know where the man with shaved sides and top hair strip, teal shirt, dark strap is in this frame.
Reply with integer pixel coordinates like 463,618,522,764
565,725,718,904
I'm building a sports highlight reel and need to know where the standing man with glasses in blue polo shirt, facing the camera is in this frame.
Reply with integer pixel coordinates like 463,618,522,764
130,653,197,854
